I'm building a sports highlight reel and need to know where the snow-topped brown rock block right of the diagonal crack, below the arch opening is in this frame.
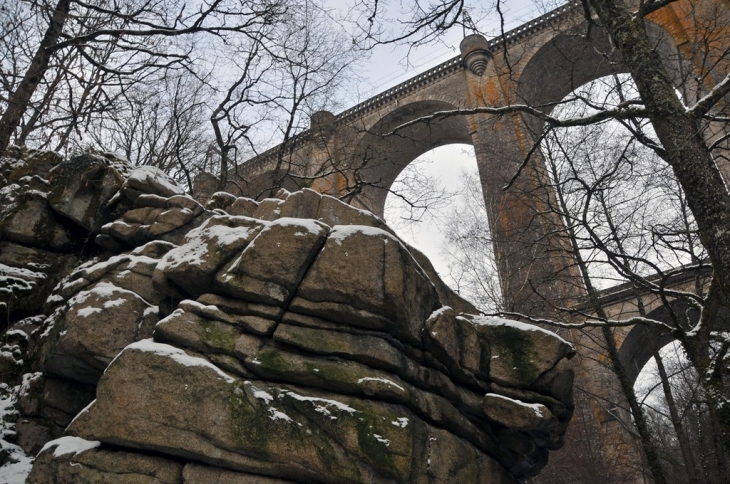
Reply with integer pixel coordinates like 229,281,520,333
290,225,439,345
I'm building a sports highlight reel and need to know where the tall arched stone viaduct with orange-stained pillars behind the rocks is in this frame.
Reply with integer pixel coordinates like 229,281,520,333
196,0,730,476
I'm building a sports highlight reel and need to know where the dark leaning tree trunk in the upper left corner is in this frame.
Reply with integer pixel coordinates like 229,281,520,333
0,0,71,154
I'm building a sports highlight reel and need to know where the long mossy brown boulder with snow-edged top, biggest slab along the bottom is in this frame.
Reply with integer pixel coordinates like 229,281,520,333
69,342,513,483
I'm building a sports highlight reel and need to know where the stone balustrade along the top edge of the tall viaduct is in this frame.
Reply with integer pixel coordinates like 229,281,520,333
236,1,581,175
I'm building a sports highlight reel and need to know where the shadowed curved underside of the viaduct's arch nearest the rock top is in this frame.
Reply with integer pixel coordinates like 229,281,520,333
350,100,473,215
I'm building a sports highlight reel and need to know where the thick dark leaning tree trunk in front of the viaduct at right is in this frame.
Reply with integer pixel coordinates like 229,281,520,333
590,0,730,449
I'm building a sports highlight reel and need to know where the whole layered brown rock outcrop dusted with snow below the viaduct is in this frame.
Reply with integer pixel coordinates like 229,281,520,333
0,148,574,484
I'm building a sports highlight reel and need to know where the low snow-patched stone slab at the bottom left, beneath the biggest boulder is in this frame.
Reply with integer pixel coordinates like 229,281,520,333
26,437,182,484
